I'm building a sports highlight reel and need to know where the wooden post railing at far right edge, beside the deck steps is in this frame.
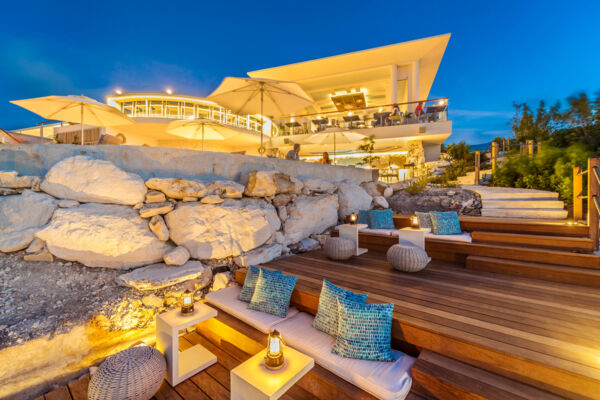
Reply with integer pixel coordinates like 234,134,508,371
573,157,600,250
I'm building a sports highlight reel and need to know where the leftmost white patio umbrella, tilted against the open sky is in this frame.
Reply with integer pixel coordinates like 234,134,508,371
11,95,134,145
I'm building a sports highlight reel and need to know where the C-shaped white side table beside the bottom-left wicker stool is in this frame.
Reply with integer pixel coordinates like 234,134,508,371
156,303,217,386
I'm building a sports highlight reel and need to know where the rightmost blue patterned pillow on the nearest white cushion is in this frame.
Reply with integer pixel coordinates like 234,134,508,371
332,299,394,361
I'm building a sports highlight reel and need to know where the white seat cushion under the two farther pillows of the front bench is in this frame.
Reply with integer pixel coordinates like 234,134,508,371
206,285,298,333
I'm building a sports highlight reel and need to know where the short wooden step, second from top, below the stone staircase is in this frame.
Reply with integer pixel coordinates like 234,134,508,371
471,231,594,252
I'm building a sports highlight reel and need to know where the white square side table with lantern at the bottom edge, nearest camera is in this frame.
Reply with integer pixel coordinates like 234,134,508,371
231,347,315,400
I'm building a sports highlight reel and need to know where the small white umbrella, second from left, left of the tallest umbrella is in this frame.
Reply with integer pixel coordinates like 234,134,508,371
167,118,251,151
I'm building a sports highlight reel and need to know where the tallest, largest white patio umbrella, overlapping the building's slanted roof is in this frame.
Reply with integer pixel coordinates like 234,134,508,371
208,77,314,156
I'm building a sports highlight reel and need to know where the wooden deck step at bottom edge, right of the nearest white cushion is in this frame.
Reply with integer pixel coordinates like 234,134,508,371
412,350,561,400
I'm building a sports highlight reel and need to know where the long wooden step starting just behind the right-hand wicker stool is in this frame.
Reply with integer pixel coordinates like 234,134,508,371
425,239,600,269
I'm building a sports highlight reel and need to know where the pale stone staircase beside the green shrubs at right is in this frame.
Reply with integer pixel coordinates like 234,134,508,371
462,185,567,219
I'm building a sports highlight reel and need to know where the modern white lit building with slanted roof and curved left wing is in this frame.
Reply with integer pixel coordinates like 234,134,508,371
9,34,452,168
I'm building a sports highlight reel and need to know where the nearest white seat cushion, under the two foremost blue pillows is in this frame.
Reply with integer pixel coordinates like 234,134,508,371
277,312,415,400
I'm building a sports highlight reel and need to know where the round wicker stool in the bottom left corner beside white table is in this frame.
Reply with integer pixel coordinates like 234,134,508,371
88,346,167,400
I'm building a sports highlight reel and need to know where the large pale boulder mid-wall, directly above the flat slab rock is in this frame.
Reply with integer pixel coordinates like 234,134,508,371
165,203,279,260
